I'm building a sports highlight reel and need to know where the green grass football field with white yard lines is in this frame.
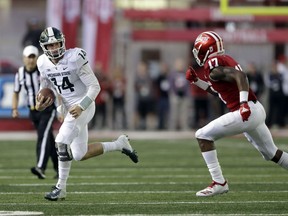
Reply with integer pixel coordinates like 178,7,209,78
0,138,288,215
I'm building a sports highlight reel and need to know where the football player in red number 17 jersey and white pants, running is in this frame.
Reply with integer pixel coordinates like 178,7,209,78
186,31,288,197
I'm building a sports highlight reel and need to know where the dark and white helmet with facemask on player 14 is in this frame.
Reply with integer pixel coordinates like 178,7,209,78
39,27,66,59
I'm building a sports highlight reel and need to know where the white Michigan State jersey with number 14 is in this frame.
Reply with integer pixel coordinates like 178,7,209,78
37,48,100,109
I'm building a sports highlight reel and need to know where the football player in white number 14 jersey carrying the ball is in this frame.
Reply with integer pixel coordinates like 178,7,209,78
36,27,138,201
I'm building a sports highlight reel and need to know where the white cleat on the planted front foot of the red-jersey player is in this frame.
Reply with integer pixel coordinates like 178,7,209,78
196,181,229,197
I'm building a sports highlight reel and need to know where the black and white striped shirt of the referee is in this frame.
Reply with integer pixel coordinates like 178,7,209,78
14,66,40,110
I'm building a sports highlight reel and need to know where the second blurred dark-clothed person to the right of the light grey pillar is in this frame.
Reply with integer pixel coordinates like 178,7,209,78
155,63,170,130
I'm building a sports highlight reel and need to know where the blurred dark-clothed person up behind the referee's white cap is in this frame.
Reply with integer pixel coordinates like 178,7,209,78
22,18,42,52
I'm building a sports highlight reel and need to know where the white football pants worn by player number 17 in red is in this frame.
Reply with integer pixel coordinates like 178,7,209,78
195,101,278,160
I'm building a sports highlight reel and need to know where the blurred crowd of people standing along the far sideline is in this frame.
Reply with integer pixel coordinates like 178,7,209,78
0,19,288,130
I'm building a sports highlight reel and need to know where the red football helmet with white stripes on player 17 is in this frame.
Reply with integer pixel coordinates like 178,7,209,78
192,31,225,66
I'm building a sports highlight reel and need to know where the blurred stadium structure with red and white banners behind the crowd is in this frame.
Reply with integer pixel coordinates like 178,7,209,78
0,0,288,131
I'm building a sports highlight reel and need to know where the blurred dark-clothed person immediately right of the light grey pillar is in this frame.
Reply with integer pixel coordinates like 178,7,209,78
135,62,153,130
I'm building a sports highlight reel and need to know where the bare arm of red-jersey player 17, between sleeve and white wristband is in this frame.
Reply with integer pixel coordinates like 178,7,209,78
210,66,249,92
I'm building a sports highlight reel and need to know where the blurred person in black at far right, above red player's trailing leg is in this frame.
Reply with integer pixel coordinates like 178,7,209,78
266,63,285,128
